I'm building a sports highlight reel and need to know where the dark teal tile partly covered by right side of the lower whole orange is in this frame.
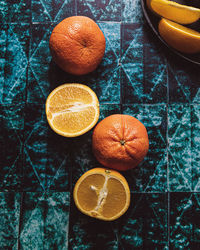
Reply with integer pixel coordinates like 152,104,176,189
123,105,167,192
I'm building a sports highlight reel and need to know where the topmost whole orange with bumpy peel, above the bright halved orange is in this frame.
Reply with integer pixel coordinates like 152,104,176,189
49,16,106,75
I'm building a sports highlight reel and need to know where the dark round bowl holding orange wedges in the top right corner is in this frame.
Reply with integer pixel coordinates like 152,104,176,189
141,0,200,66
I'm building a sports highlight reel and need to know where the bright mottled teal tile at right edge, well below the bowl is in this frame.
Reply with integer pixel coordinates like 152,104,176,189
168,104,200,192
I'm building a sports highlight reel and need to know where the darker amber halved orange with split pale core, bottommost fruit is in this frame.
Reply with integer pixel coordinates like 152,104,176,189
73,168,130,221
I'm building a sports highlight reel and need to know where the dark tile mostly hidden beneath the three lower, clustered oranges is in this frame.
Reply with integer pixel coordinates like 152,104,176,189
71,105,120,186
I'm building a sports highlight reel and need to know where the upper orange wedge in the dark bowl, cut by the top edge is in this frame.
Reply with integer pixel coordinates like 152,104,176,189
147,0,200,24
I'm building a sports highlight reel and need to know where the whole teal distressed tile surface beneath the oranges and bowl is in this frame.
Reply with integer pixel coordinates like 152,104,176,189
0,0,200,250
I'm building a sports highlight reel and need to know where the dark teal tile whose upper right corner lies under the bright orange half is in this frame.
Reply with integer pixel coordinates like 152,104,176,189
23,104,71,191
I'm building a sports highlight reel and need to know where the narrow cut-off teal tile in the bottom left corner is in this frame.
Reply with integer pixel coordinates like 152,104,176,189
0,192,20,250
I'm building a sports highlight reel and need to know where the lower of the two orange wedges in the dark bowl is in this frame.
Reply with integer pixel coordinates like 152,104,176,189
158,18,200,54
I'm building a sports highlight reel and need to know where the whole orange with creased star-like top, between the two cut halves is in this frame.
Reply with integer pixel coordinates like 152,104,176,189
92,114,149,171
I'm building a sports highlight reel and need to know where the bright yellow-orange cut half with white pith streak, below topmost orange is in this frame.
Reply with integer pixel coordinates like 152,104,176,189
46,83,99,137
